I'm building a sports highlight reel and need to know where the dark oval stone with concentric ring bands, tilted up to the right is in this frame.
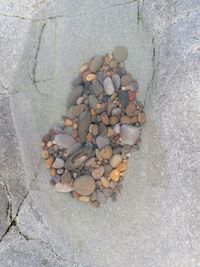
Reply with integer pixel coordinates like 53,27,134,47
65,145,93,171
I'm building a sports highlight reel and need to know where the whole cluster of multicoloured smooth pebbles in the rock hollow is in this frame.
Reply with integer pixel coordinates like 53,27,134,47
42,46,145,207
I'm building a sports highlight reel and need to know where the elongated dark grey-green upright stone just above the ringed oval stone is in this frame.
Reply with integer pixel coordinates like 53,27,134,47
78,111,91,143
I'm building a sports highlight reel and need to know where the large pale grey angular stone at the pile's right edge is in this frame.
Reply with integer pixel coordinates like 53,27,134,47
120,124,140,145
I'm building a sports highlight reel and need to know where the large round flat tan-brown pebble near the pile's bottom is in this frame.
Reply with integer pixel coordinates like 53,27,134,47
73,175,95,196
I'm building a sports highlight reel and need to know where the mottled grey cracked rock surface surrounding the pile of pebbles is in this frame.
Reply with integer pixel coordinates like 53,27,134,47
0,0,200,267
